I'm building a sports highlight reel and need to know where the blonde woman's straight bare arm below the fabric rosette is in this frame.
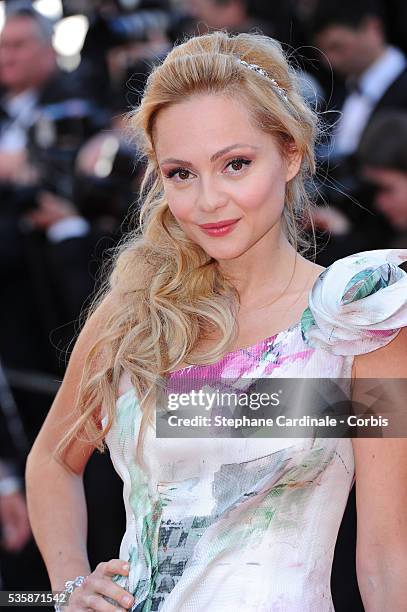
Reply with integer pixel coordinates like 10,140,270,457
352,328,407,612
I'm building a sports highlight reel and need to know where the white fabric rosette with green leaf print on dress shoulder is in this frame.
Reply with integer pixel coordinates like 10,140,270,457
301,249,407,355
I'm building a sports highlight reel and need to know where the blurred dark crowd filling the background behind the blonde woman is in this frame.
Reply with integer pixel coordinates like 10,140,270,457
0,0,407,612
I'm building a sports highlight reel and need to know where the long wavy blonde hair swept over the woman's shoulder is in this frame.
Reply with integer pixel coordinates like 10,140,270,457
55,30,318,462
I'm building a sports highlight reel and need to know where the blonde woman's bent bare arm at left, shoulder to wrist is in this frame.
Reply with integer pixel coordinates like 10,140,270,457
25,298,115,590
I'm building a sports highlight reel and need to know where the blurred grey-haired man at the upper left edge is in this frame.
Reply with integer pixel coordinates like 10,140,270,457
0,4,83,180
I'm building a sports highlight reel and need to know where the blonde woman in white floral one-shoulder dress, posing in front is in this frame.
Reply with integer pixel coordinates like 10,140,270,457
26,31,407,612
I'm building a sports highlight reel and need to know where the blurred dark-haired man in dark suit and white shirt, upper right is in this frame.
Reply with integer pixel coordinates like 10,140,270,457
302,0,407,265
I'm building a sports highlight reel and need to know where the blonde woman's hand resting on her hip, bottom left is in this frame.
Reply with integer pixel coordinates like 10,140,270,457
64,559,134,612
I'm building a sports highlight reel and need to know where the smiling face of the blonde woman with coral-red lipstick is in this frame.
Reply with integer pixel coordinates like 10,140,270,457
154,94,301,261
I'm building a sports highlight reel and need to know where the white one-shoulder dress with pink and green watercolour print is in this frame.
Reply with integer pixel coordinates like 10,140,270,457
102,249,407,612
